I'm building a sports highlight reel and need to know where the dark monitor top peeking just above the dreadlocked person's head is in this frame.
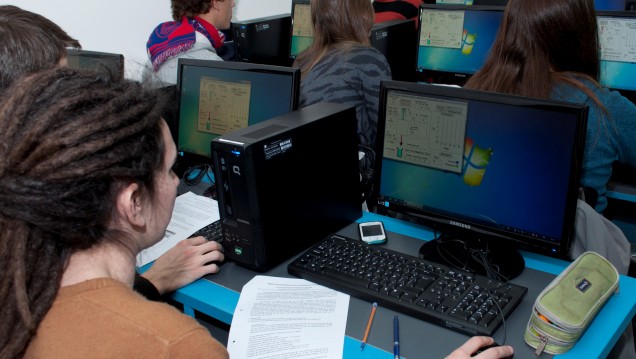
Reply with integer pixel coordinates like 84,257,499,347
66,49,124,80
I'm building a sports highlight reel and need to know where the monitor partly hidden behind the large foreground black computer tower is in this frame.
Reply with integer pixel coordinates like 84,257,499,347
177,59,300,172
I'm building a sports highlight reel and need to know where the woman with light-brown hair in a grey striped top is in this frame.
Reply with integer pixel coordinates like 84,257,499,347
294,0,391,155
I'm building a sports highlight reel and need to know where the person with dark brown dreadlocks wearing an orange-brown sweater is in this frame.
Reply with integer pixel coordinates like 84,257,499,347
0,67,228,358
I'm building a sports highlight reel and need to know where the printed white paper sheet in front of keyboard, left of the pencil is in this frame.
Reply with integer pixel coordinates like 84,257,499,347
227,276,349,359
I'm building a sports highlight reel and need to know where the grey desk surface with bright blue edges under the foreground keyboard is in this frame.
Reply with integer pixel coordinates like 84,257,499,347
173,212,636,358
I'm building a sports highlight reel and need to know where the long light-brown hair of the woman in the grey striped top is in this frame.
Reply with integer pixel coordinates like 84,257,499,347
296,0,375,74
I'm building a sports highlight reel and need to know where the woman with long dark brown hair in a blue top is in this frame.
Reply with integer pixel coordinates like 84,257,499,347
465,0,636,212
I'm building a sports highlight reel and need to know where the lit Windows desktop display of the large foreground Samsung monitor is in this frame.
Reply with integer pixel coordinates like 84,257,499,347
378,84,585,256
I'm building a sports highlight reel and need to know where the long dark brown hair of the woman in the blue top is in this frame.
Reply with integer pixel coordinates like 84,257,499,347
466,0,600,98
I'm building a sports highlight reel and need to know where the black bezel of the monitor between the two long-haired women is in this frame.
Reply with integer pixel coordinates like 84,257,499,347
415,4,506,86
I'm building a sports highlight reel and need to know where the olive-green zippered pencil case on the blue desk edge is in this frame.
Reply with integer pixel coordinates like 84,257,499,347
524,252,619,358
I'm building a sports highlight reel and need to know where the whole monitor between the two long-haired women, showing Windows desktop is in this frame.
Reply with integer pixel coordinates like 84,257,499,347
416,4,504,86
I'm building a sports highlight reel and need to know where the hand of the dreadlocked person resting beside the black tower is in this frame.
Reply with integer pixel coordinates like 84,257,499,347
142,236,225,294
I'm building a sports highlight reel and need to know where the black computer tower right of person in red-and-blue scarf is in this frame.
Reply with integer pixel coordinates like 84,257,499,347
232,14,291,66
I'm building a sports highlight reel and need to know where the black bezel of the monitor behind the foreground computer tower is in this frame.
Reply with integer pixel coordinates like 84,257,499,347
175,58,300,166
